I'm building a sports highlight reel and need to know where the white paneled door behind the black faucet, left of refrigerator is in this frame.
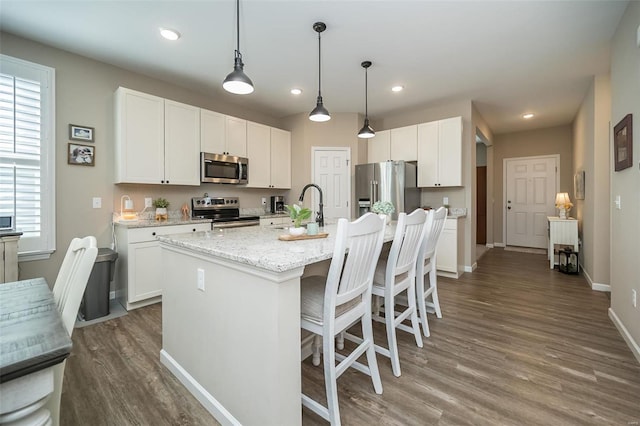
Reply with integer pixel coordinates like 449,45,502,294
310,147,351,219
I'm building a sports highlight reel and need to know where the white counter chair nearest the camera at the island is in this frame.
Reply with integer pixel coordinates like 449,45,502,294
300,213,384,425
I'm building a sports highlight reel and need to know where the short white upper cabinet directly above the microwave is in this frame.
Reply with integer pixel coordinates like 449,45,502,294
200,109,247,157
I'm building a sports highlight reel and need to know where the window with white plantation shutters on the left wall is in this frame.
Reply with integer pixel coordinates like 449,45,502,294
0,55,55,260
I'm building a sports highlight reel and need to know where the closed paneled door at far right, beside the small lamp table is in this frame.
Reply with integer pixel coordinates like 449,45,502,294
504,156,559,248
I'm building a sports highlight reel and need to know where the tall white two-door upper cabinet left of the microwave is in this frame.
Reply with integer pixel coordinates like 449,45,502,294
115,87,200,185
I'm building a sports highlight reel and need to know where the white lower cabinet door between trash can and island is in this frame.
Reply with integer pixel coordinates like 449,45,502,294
128,241,162,303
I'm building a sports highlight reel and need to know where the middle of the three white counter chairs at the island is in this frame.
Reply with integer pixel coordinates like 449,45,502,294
372,209,427,377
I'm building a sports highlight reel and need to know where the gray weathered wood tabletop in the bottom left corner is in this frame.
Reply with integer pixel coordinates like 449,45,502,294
0,278,71,383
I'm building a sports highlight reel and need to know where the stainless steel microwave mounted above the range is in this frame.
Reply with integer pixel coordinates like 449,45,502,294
200,152,249,185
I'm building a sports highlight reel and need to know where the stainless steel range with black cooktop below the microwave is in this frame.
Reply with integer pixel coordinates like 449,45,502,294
191,194,260,228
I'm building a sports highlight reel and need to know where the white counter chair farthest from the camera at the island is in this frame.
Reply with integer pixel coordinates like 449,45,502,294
416,207,447,337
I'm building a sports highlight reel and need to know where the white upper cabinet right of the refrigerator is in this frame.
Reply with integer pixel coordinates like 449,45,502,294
418,117,462,188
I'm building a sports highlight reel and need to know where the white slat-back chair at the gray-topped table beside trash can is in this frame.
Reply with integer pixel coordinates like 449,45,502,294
46,236,98,426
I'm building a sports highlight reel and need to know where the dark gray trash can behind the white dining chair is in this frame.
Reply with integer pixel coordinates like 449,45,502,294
80,248,118,321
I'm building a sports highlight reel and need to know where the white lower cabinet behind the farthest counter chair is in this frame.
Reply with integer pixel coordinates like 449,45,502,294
436,217,464,278
